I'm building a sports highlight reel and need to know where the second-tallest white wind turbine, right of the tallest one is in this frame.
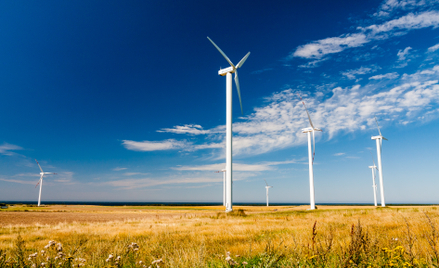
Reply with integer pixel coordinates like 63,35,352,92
297,93,322,209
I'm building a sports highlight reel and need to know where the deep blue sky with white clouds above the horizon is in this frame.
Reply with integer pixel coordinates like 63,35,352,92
0,0,439,203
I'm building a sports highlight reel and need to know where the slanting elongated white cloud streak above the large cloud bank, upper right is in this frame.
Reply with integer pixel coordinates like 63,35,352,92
290,11,439,59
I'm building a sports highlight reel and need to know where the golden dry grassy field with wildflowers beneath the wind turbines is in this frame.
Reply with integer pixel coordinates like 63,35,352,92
0,206,439,267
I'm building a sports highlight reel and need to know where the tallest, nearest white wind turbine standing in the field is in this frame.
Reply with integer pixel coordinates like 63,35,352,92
207,37,250,212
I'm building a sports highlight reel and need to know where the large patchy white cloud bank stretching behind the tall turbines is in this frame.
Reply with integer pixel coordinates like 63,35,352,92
122,65,439,158
